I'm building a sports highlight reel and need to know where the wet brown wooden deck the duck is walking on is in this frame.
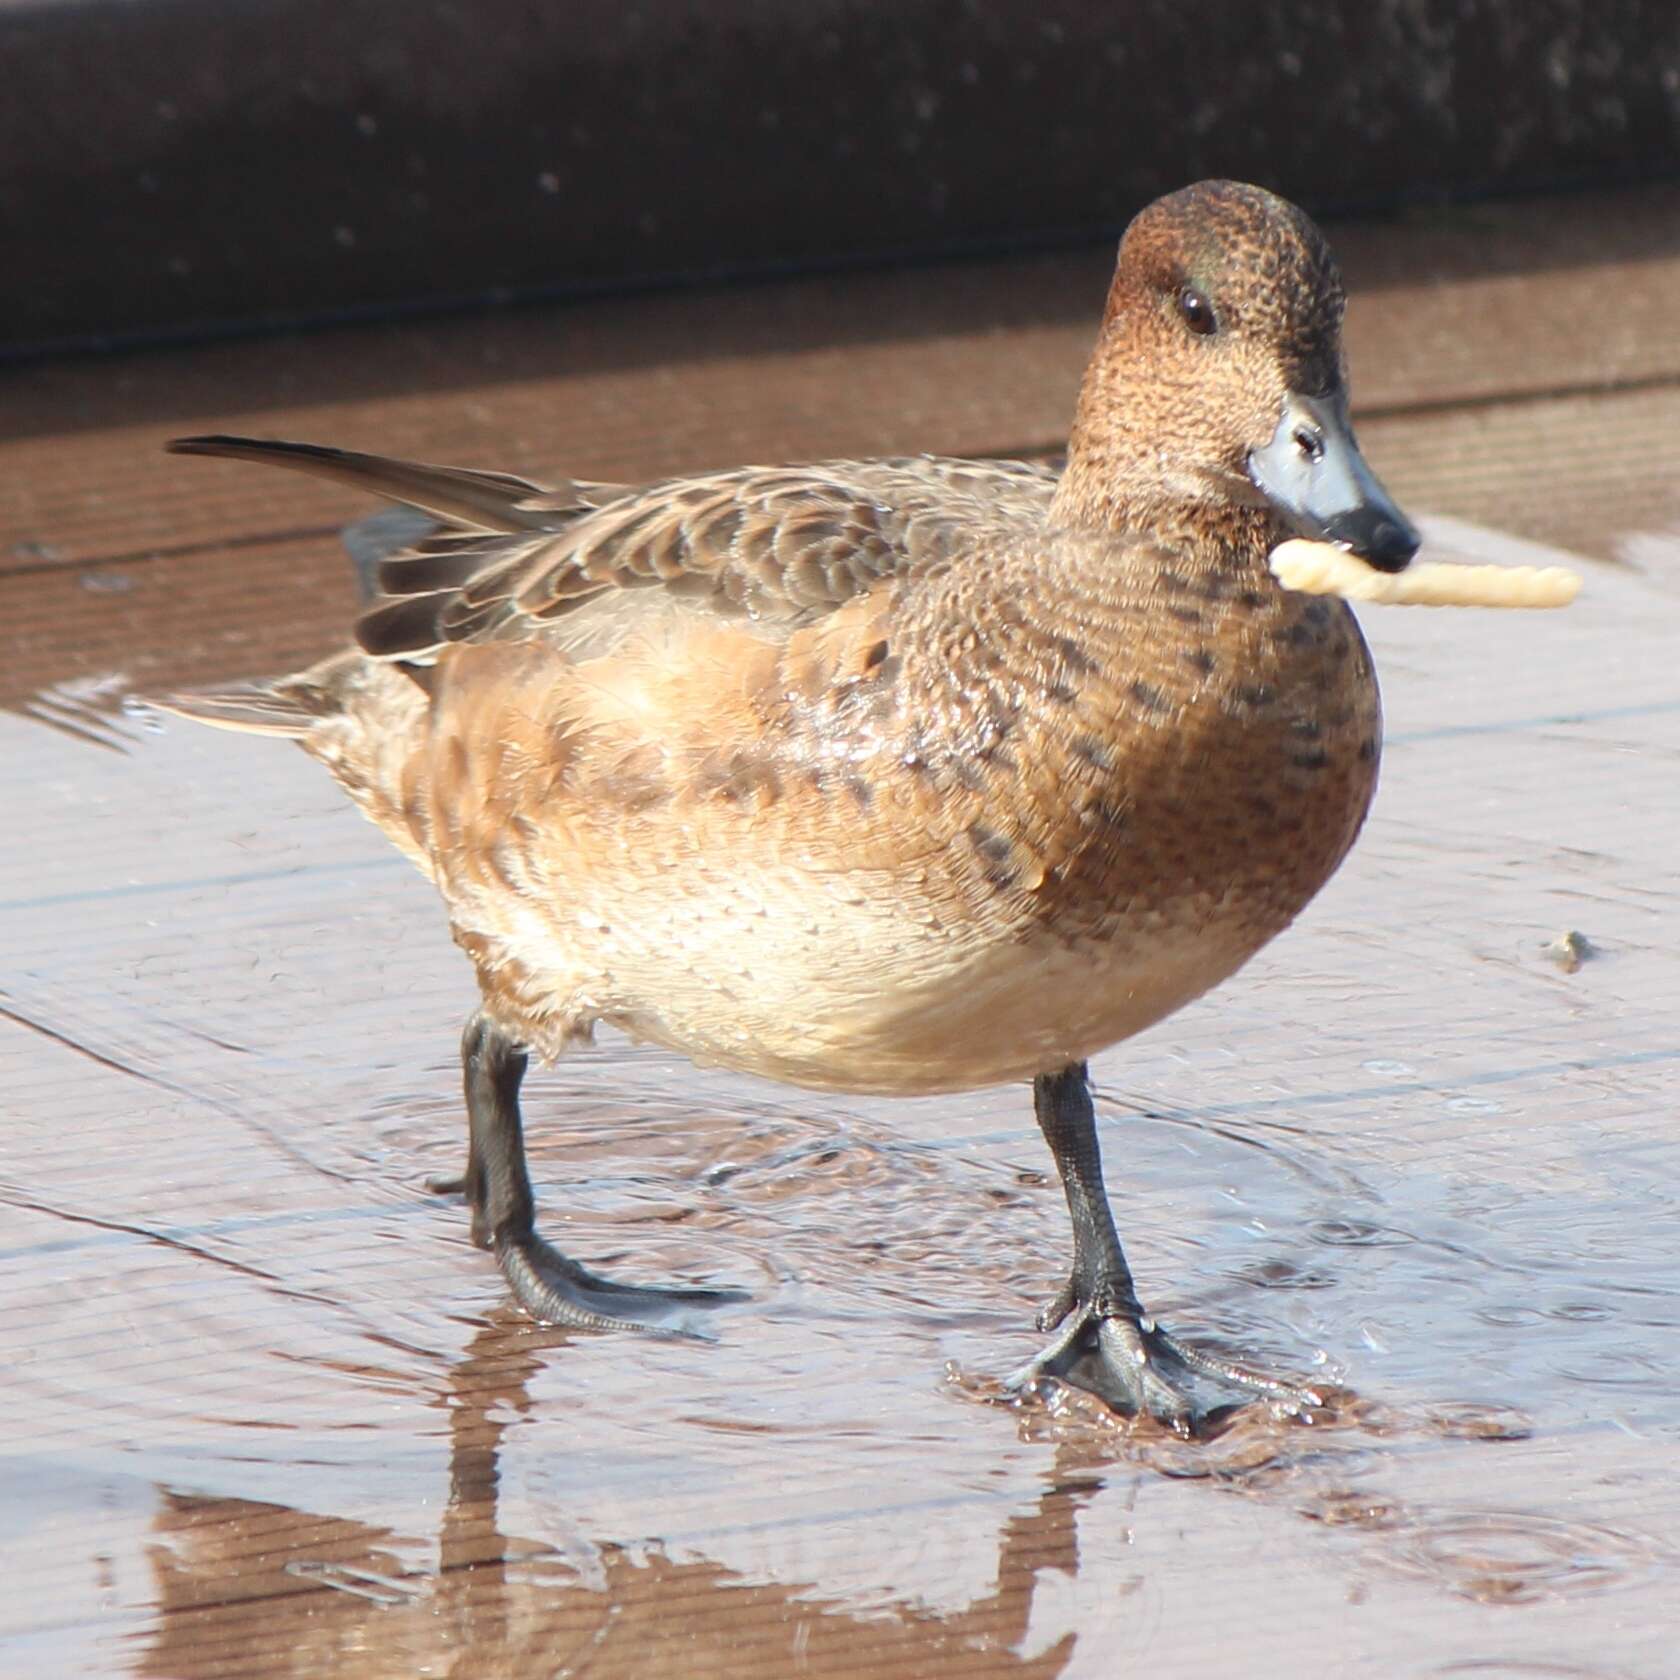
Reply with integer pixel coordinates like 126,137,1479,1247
0,188,1680,1680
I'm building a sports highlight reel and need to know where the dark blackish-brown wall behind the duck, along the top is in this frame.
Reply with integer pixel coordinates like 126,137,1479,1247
0,0,1680,354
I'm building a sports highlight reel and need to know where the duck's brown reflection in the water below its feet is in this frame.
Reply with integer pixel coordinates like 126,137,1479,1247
136,1314,1102,1680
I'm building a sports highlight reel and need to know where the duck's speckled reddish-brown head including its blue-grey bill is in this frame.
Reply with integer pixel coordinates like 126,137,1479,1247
1060,181,1418,571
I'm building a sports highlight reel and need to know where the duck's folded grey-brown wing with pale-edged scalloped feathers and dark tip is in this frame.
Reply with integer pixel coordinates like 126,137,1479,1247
170,437,1055,667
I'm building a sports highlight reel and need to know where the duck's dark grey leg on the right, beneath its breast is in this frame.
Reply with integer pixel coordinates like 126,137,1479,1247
1010,1062,1319,1435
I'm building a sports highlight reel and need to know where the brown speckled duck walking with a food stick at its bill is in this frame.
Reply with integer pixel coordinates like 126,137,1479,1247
160,180,1418,1433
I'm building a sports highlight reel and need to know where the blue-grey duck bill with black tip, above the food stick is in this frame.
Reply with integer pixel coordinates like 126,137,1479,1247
1248,391,1418,571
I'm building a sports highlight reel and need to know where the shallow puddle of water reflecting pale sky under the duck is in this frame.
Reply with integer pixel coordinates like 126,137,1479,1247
0,539,1680,1680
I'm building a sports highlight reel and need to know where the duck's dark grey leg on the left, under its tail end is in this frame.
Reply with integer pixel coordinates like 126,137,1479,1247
432,1013,746,1334
